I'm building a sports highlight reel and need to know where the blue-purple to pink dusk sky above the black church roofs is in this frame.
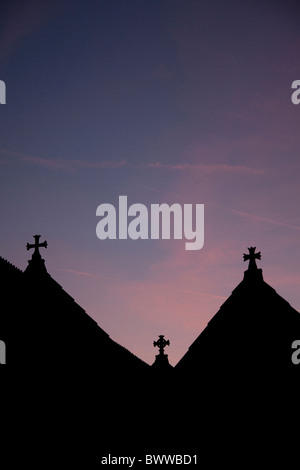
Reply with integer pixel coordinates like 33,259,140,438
0,0,300,365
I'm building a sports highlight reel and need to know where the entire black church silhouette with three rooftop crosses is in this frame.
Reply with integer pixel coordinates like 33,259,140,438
0,239,300,469
